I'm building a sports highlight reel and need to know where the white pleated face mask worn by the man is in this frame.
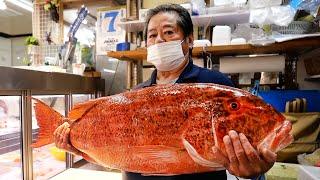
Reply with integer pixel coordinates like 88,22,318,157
147,40,185,71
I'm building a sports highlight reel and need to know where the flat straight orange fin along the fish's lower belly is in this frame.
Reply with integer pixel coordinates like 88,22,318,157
134,145,179,163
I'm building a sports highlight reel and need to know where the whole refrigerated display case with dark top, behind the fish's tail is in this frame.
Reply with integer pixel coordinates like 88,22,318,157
0,67,105,180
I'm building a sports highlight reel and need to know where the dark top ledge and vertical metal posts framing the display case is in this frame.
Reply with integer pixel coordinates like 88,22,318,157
0,66,105,180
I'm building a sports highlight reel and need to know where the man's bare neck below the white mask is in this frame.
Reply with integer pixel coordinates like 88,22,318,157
157,56,189,81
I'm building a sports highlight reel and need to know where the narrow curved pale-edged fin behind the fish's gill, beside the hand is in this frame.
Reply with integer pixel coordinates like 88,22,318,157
182,139,221,168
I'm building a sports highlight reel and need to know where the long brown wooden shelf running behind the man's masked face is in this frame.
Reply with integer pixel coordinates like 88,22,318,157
107,36,320,61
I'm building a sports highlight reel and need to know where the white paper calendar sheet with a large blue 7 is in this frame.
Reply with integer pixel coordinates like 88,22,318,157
97,9,126,55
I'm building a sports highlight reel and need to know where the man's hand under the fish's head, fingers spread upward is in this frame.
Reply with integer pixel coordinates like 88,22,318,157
213,130,277,178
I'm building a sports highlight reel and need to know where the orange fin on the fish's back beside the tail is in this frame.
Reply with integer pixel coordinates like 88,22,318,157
68,100,99,122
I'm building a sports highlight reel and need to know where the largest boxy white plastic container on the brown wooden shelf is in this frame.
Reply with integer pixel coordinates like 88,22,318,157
212,26,231,46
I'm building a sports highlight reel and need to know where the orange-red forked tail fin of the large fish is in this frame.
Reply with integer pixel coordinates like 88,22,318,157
31,98,64,148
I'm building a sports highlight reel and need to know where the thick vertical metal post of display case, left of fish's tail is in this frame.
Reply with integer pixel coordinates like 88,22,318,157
21,90,33,180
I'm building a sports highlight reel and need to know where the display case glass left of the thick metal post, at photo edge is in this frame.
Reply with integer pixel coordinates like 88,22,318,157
0,96,22,179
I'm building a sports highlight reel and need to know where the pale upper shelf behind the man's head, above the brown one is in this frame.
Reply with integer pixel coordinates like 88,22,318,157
118,10,250,32
